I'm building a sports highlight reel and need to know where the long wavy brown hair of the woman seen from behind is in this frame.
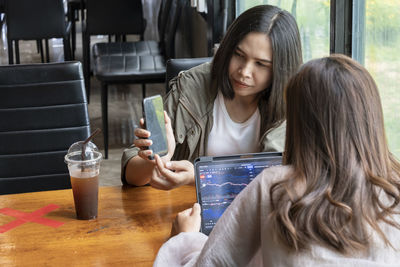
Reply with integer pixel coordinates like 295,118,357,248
270,55,400,254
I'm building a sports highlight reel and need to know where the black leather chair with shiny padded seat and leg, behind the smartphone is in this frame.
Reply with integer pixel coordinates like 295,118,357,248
93,0,182,159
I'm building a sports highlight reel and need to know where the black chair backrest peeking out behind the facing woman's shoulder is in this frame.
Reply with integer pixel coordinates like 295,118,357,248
165,57,212,93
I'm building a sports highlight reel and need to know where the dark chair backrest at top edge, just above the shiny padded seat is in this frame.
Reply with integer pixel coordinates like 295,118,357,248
86,0,145,35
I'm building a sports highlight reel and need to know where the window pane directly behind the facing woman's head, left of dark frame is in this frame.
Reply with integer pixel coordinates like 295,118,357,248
236,0,330,62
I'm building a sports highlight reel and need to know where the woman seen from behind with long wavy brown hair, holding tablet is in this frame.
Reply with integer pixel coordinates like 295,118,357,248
155,55,400,266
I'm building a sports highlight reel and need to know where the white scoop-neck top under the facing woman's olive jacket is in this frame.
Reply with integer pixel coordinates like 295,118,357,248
206,92,261,156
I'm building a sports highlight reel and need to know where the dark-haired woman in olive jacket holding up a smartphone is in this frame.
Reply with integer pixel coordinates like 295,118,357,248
121,5,302,189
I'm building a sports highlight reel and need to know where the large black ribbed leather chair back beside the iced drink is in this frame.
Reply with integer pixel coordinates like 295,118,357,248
0,62,90,194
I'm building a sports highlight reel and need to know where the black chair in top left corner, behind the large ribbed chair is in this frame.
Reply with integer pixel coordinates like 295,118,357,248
6,0,71,64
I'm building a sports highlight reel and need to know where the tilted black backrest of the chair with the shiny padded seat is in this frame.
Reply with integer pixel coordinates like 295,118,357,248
160,0,186,59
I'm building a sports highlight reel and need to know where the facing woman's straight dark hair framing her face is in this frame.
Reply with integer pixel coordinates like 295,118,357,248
212,5,302,131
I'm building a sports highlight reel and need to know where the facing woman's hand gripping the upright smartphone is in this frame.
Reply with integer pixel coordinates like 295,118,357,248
133,111,175,162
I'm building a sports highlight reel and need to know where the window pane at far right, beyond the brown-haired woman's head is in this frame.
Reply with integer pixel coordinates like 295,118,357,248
352,0,400,158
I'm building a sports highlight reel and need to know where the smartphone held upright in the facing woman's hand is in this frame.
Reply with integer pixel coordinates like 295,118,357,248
143,95,168,159
